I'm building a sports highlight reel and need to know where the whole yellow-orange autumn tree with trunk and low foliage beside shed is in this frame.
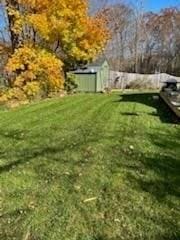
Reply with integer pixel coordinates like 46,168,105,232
0,0,108,102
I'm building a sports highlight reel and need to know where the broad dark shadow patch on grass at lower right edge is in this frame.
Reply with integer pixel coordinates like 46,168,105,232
126,155,180,202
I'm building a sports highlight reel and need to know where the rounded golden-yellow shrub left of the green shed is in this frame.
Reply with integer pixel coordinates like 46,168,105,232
5,45,64,100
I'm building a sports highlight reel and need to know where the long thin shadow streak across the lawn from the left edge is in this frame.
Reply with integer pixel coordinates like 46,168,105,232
0,125,101,174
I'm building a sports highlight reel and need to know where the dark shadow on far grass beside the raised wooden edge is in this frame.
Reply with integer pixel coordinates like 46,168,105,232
119,93,177,123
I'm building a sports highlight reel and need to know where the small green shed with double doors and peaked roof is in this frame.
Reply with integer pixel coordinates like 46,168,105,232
73,58,110,92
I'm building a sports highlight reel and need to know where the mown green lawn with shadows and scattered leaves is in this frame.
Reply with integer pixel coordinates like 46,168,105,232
0,93,180,240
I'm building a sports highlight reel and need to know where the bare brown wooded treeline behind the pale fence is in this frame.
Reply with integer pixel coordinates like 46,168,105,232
96,0,180,76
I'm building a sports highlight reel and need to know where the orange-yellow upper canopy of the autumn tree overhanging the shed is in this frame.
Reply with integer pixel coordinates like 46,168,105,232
15,0,109,61
